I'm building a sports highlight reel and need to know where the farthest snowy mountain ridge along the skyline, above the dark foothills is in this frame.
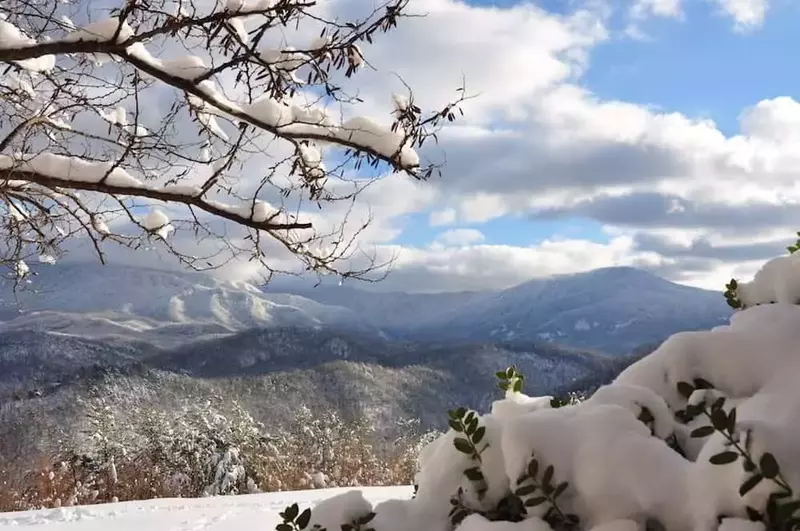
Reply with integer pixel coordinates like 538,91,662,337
0,264,730,353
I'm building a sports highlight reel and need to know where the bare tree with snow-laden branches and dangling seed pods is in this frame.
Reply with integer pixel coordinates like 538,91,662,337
0,0,464,286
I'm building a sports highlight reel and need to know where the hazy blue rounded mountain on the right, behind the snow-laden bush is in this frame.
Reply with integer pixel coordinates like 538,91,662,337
284,267,731,354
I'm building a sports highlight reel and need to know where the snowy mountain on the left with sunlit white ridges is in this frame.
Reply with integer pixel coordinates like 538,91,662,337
0,264,379,347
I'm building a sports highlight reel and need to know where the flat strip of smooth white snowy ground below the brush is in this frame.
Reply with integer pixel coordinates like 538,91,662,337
0,487,413,531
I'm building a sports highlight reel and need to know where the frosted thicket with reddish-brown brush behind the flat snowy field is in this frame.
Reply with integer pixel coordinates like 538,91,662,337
0,392,436,511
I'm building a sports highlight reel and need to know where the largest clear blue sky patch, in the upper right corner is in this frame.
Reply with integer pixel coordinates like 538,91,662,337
583,1,800,134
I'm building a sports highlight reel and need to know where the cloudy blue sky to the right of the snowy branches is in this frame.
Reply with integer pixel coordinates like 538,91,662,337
42,0,800,291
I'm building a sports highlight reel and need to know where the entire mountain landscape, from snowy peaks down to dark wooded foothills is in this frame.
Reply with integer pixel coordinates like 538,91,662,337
0,264,730,464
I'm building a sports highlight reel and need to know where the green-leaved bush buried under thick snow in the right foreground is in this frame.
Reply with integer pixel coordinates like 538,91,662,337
274,247,800,531
